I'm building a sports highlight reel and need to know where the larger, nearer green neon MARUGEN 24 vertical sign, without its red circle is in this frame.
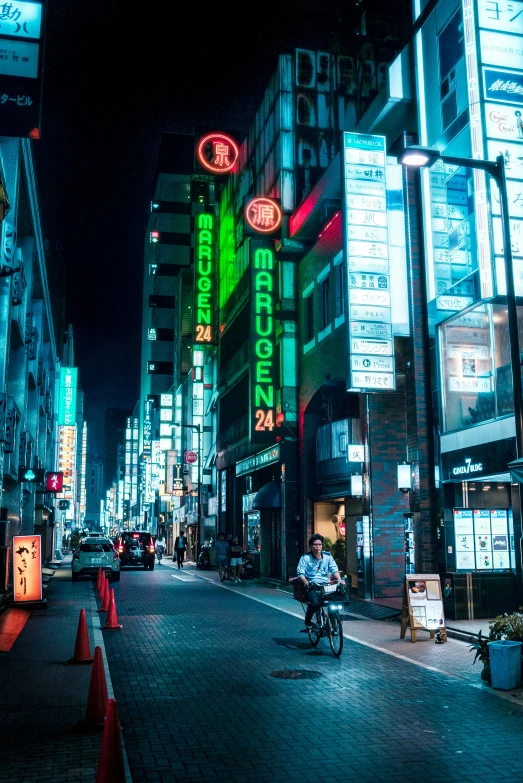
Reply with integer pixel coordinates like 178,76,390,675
249,240,277,443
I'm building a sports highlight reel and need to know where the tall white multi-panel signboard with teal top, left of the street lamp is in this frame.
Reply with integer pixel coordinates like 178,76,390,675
342,133,396,391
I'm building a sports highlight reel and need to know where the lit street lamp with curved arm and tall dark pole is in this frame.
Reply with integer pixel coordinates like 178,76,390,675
398,145,523,468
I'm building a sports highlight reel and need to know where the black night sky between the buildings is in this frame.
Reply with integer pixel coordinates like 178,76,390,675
35,0,360,453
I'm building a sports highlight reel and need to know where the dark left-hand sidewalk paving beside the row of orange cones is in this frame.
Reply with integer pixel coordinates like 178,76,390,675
0,559,106,783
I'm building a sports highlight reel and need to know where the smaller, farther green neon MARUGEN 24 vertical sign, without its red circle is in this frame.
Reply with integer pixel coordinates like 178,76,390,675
194,213,214,344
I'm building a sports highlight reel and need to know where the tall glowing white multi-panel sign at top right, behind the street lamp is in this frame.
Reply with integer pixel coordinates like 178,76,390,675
462,0,523,298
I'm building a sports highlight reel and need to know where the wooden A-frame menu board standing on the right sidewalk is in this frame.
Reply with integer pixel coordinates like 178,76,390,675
401,574,447,642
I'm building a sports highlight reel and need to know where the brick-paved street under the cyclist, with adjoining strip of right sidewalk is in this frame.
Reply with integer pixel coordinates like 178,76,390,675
104,565,523,783
